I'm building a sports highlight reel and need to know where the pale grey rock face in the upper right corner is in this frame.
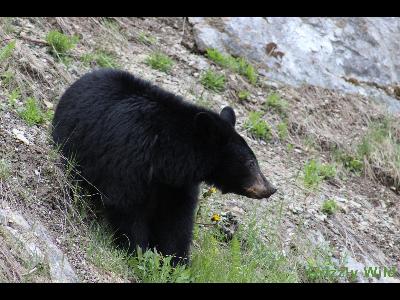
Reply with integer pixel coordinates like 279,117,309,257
189,17,400,112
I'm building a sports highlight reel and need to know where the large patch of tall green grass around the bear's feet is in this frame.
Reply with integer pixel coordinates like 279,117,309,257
87,218,298,283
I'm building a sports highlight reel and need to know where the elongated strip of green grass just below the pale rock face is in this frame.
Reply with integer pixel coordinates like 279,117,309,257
206,49,258,85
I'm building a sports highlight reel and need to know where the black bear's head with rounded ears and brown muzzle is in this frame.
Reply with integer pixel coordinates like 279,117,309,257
195,106,277,199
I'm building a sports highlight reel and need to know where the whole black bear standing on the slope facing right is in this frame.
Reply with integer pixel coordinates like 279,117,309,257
52,69,276,264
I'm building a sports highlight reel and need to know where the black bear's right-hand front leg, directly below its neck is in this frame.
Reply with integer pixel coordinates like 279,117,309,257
150,186,198,266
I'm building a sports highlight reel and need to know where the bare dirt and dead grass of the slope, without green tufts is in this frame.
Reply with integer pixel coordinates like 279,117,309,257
0,18,400,282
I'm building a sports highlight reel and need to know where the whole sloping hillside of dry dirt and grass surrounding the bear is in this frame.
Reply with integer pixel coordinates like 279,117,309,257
0,18,400,282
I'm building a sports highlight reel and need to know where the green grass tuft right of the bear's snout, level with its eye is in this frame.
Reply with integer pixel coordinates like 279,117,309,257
303,159,336,188
